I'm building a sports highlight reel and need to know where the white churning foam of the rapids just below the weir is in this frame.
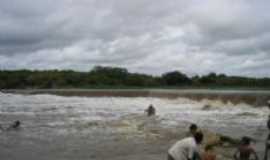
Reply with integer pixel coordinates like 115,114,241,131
0,93,268,139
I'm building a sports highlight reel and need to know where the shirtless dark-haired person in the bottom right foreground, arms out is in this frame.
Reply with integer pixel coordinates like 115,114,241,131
233,137,259,160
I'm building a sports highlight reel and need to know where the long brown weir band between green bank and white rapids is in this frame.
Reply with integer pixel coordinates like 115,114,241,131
1,89,270,106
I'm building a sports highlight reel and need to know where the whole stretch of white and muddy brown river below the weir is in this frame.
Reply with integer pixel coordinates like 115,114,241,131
0,93,268,160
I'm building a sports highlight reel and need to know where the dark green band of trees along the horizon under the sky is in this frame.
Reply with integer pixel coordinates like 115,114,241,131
0,66,270,89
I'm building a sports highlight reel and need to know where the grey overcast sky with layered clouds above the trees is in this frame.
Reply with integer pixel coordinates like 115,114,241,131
0,0,270,77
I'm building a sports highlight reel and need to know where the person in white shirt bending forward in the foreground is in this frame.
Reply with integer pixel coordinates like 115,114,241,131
168,132,203,160
